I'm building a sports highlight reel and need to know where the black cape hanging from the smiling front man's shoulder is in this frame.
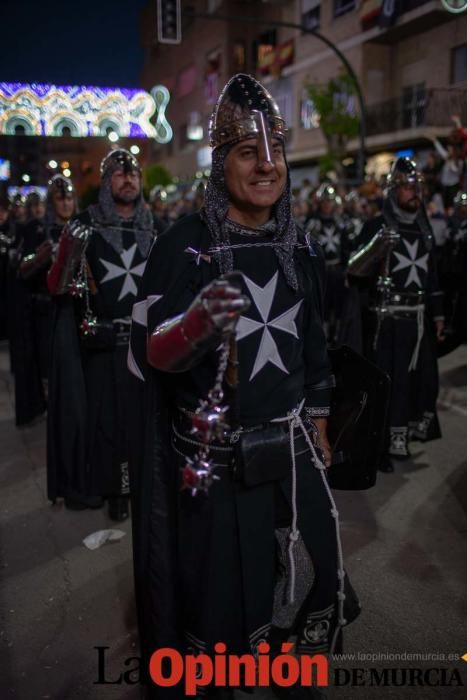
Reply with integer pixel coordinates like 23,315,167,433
129,214,360,698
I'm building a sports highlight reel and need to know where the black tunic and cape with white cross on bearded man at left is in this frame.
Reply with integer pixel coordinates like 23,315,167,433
47,211,157,502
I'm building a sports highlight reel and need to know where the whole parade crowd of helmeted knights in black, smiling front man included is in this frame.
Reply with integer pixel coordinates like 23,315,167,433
0,76,467,698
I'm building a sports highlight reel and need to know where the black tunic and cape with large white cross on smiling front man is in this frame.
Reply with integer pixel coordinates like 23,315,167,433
129,214,358,698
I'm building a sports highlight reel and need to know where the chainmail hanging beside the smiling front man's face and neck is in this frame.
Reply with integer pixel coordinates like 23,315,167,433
201,144,298,291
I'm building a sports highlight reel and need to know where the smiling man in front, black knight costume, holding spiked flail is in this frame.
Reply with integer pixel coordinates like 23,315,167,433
129,74,358,699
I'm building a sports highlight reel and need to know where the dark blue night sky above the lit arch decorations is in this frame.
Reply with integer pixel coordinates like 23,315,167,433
0,0,147,87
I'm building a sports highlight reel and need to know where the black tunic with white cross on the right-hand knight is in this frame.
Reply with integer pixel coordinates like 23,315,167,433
358,211,443,448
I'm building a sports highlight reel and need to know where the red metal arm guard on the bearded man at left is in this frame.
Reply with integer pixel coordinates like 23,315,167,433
47,221,91,295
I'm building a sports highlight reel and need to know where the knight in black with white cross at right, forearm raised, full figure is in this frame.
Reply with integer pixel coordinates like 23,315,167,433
349,158,444,471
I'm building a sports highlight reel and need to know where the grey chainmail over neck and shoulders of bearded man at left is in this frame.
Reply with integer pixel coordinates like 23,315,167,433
89,168,154,257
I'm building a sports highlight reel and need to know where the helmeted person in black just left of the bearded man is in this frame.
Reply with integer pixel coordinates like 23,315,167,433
14,175,76,426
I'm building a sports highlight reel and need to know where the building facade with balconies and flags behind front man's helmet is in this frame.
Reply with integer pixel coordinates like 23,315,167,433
142,0,467,181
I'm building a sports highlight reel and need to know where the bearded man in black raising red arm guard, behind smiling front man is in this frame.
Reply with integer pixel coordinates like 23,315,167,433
48,149,163,521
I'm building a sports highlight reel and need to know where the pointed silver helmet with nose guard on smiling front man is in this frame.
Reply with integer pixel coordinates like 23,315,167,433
209,73,287,168
